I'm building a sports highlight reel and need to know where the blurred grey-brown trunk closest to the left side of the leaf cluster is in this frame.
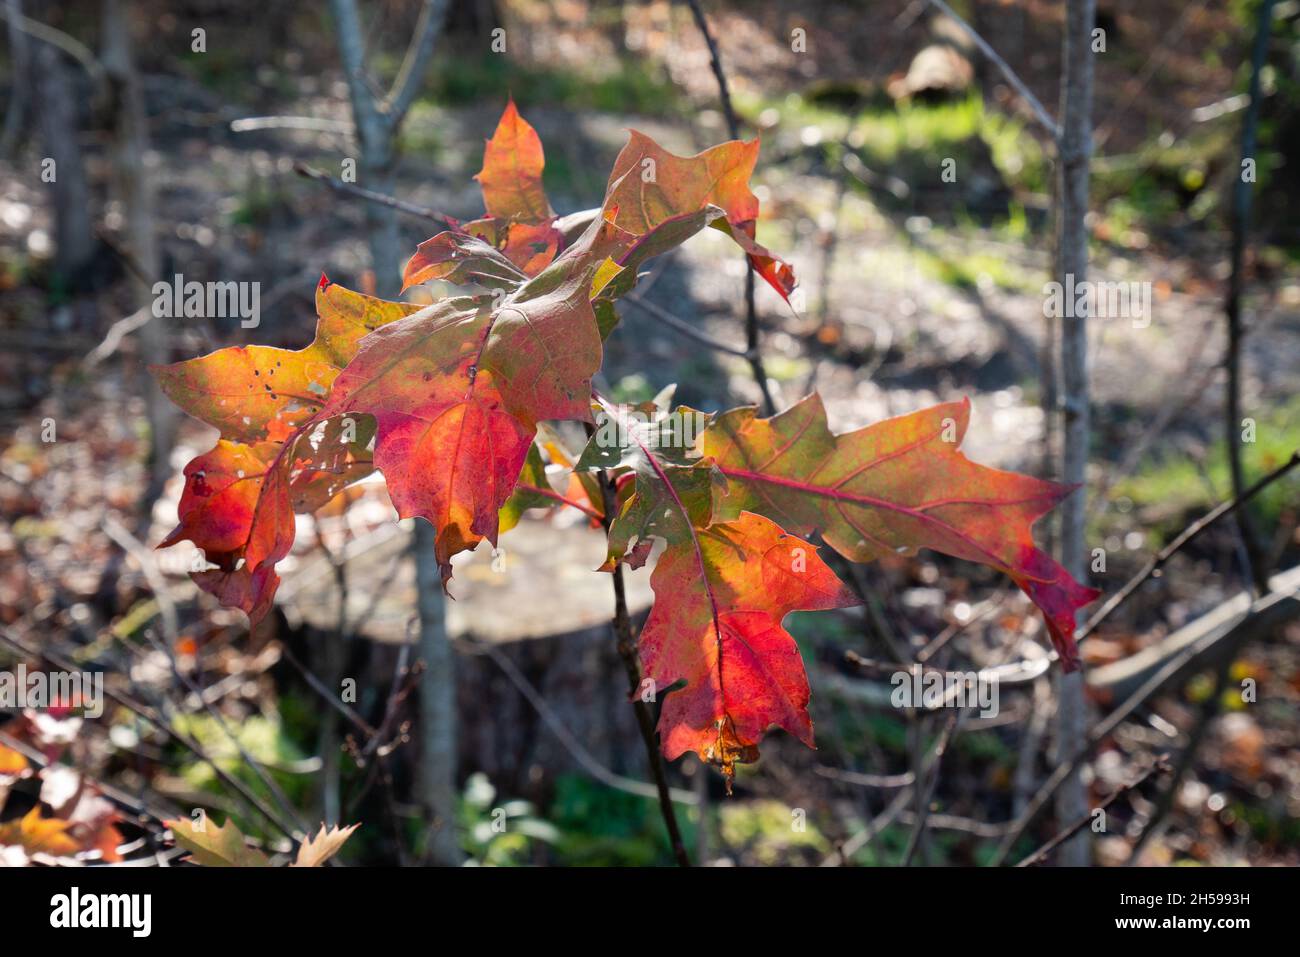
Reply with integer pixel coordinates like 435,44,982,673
101,0,177,512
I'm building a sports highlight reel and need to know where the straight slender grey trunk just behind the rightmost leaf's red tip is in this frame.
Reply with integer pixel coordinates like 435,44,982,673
1057,0,1096,867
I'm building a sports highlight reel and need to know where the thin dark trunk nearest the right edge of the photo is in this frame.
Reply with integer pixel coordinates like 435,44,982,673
1223,0,1273,594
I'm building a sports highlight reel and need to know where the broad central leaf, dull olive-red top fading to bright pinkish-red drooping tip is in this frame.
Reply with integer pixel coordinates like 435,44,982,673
322,269,602,583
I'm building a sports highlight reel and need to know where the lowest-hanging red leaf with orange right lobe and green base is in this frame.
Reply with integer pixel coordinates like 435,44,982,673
577,400,859,788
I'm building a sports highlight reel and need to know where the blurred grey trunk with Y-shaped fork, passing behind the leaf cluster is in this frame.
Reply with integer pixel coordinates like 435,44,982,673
330,0,464,865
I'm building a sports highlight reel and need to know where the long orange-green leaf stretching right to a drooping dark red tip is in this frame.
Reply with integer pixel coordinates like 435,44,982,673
701,394,1100,671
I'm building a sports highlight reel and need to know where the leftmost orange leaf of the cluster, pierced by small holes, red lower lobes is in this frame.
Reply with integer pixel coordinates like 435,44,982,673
152,277,400,623
